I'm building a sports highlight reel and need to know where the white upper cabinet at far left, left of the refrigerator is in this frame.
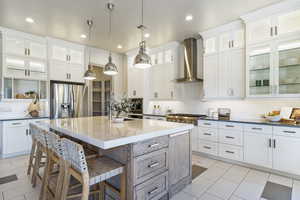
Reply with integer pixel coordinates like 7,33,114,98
3,29,48,80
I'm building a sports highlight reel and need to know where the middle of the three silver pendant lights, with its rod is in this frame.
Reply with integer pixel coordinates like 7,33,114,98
103,3,118,76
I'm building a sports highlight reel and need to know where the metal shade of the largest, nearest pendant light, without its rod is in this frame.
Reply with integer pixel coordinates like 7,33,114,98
133,41,152,69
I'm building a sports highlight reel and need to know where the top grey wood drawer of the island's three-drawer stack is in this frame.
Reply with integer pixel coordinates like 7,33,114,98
133,136,169,156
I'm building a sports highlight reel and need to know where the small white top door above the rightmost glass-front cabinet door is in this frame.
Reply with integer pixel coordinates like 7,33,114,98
277,9,300,36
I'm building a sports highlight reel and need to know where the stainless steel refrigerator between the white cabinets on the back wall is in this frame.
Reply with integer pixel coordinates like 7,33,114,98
50,81,84,119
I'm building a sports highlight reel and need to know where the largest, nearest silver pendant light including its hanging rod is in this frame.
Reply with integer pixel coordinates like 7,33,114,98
133,0,152,69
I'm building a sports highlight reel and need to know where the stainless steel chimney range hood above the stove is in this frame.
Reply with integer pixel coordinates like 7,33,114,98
176,38,203,82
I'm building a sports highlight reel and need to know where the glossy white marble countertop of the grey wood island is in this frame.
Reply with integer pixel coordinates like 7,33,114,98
41,117,193,149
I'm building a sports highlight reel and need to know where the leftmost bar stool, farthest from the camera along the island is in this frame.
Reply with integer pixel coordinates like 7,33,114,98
27,123,47,187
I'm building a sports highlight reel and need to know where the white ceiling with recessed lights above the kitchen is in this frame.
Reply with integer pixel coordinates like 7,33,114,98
0,0,280,52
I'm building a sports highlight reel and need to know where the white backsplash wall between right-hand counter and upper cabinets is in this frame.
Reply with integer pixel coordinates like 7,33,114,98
144,100,300,119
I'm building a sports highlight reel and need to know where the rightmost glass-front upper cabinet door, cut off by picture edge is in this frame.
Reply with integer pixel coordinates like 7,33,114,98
276,38,300,95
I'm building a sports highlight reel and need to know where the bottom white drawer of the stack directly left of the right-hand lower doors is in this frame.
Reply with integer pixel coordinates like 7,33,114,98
219,144,243,161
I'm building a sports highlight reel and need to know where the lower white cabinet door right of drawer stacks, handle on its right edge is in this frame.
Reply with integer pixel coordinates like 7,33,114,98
244,132,272,168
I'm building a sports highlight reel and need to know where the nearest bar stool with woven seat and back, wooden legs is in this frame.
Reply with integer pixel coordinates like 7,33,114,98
61,138,126,200
